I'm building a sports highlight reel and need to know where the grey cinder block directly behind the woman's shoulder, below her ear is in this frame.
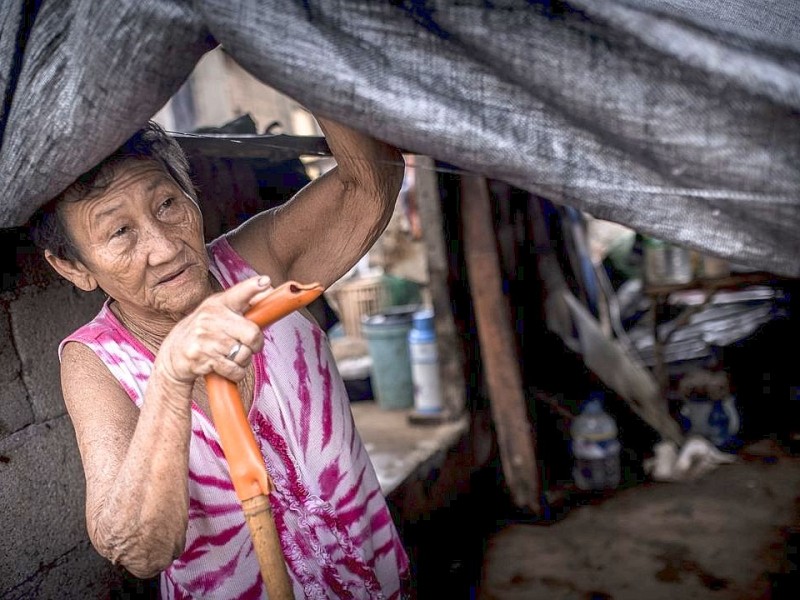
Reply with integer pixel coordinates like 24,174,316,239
9,281,104,422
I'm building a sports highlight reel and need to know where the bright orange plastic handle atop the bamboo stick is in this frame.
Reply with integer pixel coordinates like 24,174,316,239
205,281,324,501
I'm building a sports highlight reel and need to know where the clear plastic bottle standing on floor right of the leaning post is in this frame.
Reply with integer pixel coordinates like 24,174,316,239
570,394,621,491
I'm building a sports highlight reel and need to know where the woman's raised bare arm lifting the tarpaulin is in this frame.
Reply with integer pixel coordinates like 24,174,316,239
230,119,404,287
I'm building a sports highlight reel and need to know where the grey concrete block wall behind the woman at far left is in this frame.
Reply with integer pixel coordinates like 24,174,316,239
0,237,125,599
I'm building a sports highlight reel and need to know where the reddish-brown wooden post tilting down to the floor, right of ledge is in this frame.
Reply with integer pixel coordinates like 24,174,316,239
461,175,541,513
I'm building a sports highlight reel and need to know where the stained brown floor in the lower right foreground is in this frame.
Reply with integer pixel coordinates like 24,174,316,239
478,440,800,600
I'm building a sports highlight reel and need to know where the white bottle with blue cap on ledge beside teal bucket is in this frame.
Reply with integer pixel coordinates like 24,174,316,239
408,309,442,414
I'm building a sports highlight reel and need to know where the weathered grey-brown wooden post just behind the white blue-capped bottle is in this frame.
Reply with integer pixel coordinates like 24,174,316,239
413,155,465,418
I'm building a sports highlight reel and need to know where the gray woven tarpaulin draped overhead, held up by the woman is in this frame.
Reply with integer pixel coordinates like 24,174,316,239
0,0,800,276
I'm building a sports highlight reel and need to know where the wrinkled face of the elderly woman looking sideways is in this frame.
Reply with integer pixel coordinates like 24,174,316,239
63,160,211,320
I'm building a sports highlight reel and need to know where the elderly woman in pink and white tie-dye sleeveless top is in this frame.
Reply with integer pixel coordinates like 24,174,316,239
34,120,408,598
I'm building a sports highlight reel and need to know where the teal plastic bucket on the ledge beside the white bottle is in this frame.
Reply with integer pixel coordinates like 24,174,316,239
361,306,417,410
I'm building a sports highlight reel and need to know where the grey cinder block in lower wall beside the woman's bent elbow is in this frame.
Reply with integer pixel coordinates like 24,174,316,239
0,416,97,598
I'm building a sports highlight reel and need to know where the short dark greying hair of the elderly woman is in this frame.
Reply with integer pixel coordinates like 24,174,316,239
29,121,197,260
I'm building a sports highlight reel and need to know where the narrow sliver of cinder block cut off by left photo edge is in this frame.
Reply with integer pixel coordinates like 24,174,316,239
0,302,33,439
